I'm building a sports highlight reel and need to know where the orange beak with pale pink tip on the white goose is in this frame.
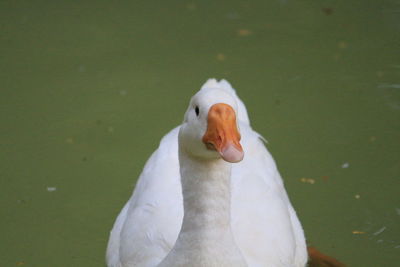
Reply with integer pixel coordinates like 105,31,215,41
203,103,244,163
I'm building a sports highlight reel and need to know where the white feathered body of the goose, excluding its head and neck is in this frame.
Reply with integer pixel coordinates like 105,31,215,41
107,80,307,267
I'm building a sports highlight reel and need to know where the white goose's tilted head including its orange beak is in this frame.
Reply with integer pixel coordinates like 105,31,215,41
179,89,244,163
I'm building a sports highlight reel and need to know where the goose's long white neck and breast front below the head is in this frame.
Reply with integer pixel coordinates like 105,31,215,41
159,148,247,267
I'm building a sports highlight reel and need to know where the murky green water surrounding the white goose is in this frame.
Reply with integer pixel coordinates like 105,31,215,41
0,0,400,267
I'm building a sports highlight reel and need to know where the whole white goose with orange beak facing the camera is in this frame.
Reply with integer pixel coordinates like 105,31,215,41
107,79,307,267
